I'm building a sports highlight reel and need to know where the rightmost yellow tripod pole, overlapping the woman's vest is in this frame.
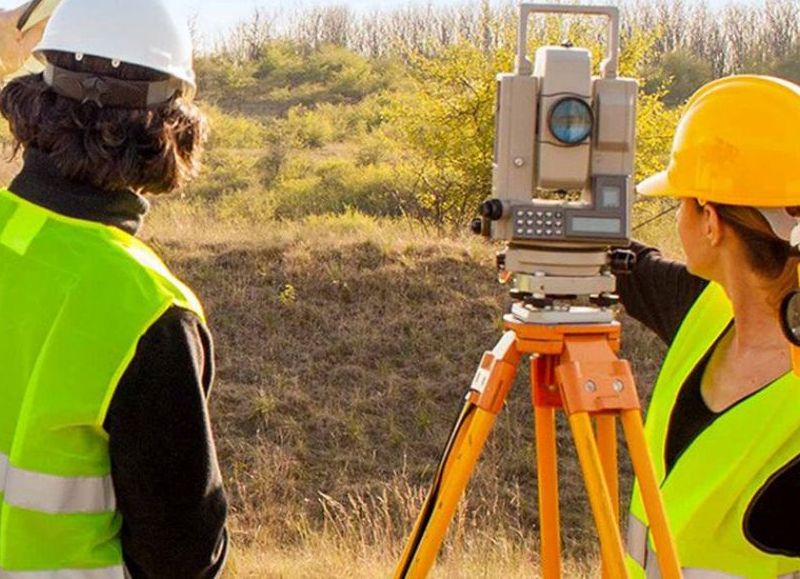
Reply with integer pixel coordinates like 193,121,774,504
622,410,682,579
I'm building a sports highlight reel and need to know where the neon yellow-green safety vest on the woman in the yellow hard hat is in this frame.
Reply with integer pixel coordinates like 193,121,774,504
627,283,800,579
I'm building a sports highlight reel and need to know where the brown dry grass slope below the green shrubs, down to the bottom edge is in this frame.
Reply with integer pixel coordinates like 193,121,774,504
146,206,662,578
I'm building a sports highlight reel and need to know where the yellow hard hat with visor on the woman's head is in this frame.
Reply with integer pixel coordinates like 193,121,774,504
637,75,800,207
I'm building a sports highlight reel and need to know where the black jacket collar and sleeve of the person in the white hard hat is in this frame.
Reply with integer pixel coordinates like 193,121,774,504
9,150,228,579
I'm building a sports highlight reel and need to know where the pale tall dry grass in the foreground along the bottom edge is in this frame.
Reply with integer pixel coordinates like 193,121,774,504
220,478,599,579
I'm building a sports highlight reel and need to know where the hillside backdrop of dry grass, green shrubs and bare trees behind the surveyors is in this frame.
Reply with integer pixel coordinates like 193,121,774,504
0,0,800,579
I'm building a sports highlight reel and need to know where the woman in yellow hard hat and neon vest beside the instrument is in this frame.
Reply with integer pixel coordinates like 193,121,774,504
619,76,800,579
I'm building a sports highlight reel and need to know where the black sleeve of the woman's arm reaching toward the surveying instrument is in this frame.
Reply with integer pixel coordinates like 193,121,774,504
617,242,708,344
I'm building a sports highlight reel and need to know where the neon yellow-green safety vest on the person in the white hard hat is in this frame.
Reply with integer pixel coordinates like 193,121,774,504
0,190,203,579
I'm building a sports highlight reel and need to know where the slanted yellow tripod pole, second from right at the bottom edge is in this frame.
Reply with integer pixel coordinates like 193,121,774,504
569,412,628,579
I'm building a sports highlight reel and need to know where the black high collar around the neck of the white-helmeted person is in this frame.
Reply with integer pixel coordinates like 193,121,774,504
8,149,150,235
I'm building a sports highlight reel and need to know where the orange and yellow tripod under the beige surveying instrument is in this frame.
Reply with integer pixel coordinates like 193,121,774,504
394,314,681,579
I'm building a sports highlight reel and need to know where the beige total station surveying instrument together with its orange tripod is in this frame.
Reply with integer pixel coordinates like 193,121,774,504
395,3,681,579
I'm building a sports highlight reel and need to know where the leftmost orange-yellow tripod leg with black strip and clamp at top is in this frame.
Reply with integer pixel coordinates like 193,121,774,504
394,332,520,579
